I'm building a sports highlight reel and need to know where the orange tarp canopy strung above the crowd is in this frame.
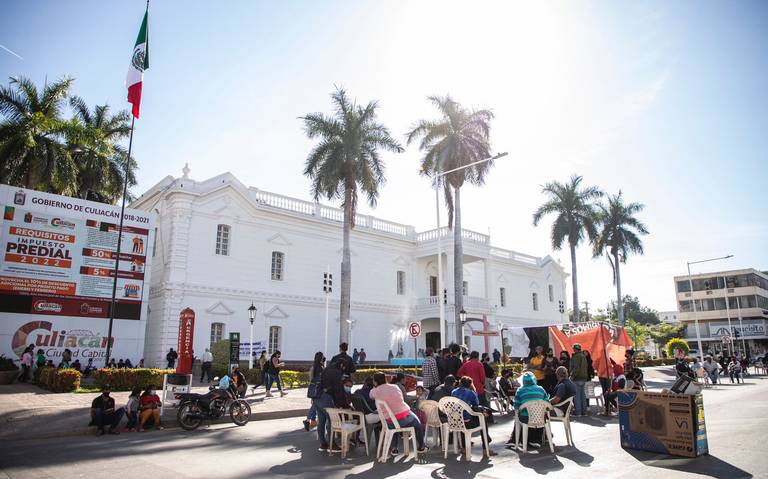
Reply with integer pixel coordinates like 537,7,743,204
549,321,632,378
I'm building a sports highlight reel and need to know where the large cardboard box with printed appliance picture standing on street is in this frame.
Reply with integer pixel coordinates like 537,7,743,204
618,391,708,457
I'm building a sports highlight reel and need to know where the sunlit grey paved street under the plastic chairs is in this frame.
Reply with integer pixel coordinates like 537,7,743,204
0,371,768,479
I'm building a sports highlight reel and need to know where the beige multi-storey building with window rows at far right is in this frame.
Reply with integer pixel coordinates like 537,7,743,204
675,269,768,356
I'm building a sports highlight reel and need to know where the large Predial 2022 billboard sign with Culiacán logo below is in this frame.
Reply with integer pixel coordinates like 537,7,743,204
0,185,154,365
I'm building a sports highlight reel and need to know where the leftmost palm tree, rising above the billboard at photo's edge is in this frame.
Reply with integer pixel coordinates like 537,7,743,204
0,77,76,194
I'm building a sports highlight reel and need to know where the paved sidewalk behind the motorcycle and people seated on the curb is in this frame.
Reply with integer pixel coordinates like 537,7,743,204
0,383,310,441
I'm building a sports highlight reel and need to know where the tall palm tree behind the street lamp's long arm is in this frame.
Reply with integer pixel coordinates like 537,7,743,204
407,95,493,344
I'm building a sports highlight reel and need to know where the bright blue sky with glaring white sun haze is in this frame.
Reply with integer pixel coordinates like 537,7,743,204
0,0,768,311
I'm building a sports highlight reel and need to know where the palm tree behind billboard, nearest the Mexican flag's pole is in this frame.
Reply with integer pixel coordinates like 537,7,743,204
67,96,136,203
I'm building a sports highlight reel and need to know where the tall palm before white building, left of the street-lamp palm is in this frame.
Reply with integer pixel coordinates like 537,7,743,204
301,88,403,343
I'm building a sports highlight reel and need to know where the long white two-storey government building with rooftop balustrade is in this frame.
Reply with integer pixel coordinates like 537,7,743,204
131,167,568,364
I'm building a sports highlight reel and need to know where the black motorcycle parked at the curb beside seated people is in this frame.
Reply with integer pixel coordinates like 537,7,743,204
174,384,251,431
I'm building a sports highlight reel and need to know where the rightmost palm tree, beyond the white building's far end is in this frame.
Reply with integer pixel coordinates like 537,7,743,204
593,191,648,326
